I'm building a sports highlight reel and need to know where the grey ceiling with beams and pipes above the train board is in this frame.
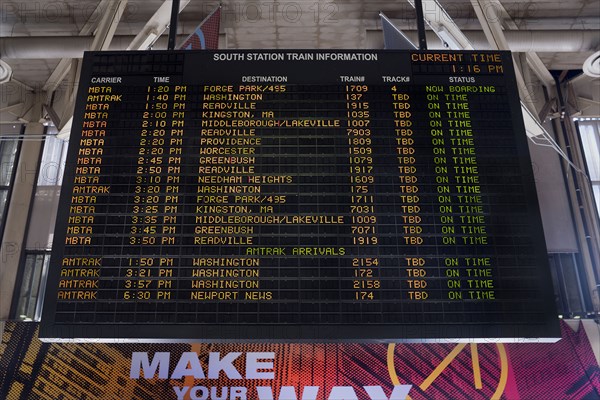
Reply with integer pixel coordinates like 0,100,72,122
0,0,600,134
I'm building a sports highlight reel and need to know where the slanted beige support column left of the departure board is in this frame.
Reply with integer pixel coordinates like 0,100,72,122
0,122,44,320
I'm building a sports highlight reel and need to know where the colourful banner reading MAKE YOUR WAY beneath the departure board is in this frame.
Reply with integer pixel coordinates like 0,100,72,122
0,322,600,400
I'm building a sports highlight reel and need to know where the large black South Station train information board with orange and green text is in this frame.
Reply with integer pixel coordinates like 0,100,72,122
40,50,560,342
